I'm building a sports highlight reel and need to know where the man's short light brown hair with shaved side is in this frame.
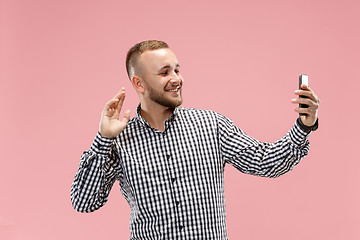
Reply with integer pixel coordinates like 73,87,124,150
126,40,169,81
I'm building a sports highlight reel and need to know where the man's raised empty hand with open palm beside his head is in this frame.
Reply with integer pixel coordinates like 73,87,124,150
99,88,130,138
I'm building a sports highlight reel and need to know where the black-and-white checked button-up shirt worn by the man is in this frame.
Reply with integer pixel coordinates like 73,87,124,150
71,105,310,240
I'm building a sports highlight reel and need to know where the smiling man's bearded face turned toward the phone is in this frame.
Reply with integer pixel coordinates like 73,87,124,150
139,48,183,108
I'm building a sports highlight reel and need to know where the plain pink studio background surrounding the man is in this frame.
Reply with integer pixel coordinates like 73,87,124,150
0,0,360,240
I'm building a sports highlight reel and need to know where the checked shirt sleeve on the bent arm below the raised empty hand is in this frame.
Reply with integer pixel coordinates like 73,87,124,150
71,133,121,212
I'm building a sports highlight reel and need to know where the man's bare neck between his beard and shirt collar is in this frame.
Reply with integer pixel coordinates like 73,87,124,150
140,102,174,132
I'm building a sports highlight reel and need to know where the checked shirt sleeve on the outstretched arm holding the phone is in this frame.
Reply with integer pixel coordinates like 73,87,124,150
218,115,310,178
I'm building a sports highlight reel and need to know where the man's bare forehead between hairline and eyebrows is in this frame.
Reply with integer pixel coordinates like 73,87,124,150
140,48,178,70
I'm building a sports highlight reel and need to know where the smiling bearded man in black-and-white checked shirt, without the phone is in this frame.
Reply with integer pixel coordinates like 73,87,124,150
71,40,319,239
